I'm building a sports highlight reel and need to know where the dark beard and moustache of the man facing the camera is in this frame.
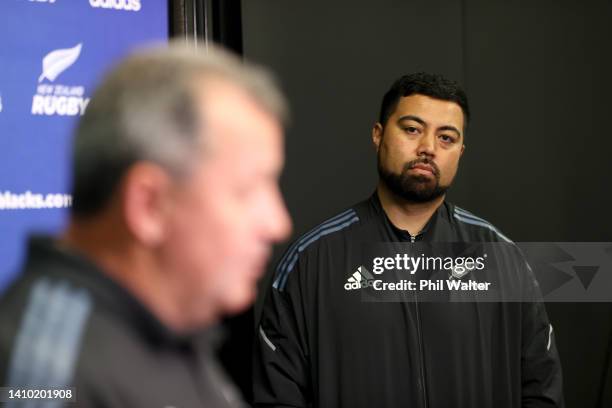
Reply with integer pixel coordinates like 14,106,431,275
378,155,450,203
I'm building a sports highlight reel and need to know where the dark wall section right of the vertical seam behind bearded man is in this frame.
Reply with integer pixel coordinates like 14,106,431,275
456,0,612,407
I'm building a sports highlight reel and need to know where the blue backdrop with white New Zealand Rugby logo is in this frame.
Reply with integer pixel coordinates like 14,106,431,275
0,0,169,291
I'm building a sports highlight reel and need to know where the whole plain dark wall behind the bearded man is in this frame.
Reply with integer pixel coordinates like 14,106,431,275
242,0,612,407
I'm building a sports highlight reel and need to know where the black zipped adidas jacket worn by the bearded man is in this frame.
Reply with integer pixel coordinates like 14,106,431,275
254,194,564,408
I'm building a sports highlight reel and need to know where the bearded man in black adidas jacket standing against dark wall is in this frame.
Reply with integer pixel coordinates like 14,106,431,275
254,73,563,408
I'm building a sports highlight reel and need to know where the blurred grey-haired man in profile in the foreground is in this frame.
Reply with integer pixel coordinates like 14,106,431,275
0,46,290,407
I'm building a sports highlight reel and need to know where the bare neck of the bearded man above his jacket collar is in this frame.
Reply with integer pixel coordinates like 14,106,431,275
376,182,444,236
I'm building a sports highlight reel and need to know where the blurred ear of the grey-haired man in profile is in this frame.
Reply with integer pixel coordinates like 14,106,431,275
121,162,172,246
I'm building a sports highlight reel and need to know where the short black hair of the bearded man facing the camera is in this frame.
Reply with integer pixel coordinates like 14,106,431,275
378,72,470,126
